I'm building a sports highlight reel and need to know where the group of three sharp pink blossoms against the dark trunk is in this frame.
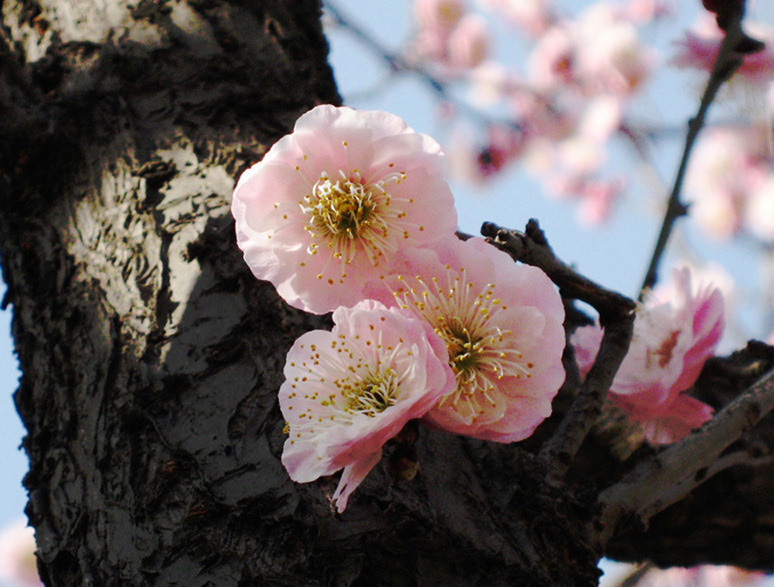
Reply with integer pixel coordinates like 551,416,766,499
232,105,565,511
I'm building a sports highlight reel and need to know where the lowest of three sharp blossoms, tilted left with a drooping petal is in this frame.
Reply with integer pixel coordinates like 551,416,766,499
279,300,454,512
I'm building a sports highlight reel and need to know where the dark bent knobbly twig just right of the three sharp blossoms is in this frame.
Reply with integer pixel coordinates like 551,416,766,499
481,220,636,484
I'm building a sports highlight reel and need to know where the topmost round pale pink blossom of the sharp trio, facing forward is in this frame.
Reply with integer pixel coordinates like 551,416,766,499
232,105,457,314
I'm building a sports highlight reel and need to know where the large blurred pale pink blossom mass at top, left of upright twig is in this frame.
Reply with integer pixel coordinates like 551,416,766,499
405,0,666,223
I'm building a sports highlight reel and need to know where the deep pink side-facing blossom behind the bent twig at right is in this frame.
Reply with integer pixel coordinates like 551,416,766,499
570,268,723,444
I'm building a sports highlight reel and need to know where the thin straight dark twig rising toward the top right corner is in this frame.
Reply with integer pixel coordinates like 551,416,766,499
640,13,749,300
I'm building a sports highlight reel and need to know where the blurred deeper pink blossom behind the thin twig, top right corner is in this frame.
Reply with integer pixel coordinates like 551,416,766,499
671,16,774,86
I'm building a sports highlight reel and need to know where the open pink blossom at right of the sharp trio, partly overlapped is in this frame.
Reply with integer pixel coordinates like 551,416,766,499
370,239,564,442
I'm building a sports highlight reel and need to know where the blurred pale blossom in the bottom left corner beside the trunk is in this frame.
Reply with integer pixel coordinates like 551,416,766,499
0,520,43,587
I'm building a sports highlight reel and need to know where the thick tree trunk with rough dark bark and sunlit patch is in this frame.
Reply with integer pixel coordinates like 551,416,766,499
0,0,774,587
